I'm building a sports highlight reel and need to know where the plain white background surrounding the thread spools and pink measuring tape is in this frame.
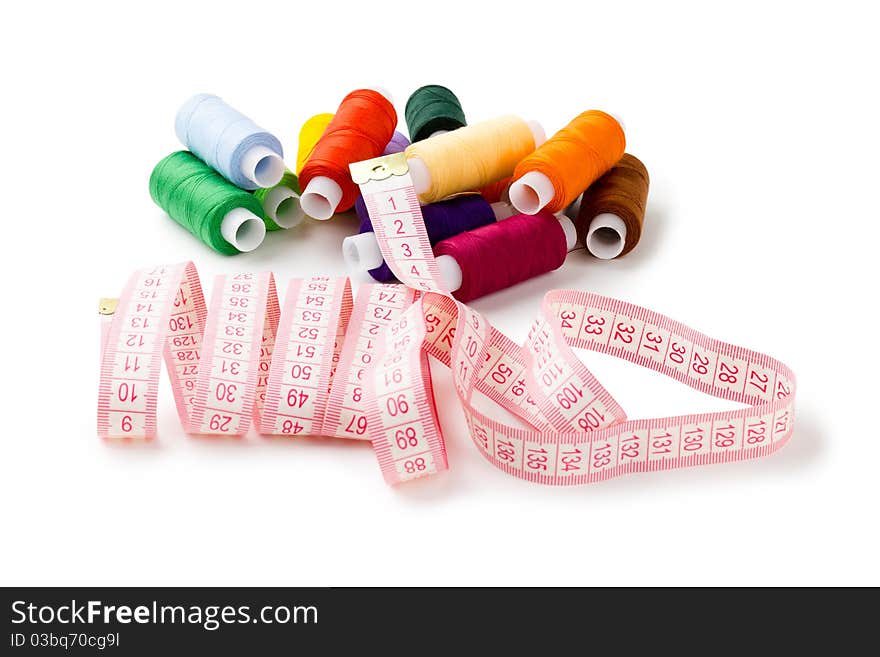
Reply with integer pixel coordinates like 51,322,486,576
0,0,880,585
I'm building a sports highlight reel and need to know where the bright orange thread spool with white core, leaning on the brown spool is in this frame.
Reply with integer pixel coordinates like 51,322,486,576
510,110,626,214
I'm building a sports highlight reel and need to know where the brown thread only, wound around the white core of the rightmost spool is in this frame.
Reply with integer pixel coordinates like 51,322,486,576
575,153,650,258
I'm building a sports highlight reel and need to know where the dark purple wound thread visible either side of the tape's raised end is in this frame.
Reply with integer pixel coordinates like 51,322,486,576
354,194,495,283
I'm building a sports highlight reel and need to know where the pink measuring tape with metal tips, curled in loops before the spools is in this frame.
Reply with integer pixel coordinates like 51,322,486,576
98,154,795,485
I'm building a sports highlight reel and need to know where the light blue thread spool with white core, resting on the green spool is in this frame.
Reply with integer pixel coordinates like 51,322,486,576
174,94,284,189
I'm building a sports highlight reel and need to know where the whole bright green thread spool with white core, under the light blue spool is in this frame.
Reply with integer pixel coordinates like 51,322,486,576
150,151,266,255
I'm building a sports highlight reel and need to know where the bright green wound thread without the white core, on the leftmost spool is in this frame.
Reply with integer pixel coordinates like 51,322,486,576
150,151,265,255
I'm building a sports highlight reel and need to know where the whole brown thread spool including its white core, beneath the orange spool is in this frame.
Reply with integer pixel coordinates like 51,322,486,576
575,153,650,260
